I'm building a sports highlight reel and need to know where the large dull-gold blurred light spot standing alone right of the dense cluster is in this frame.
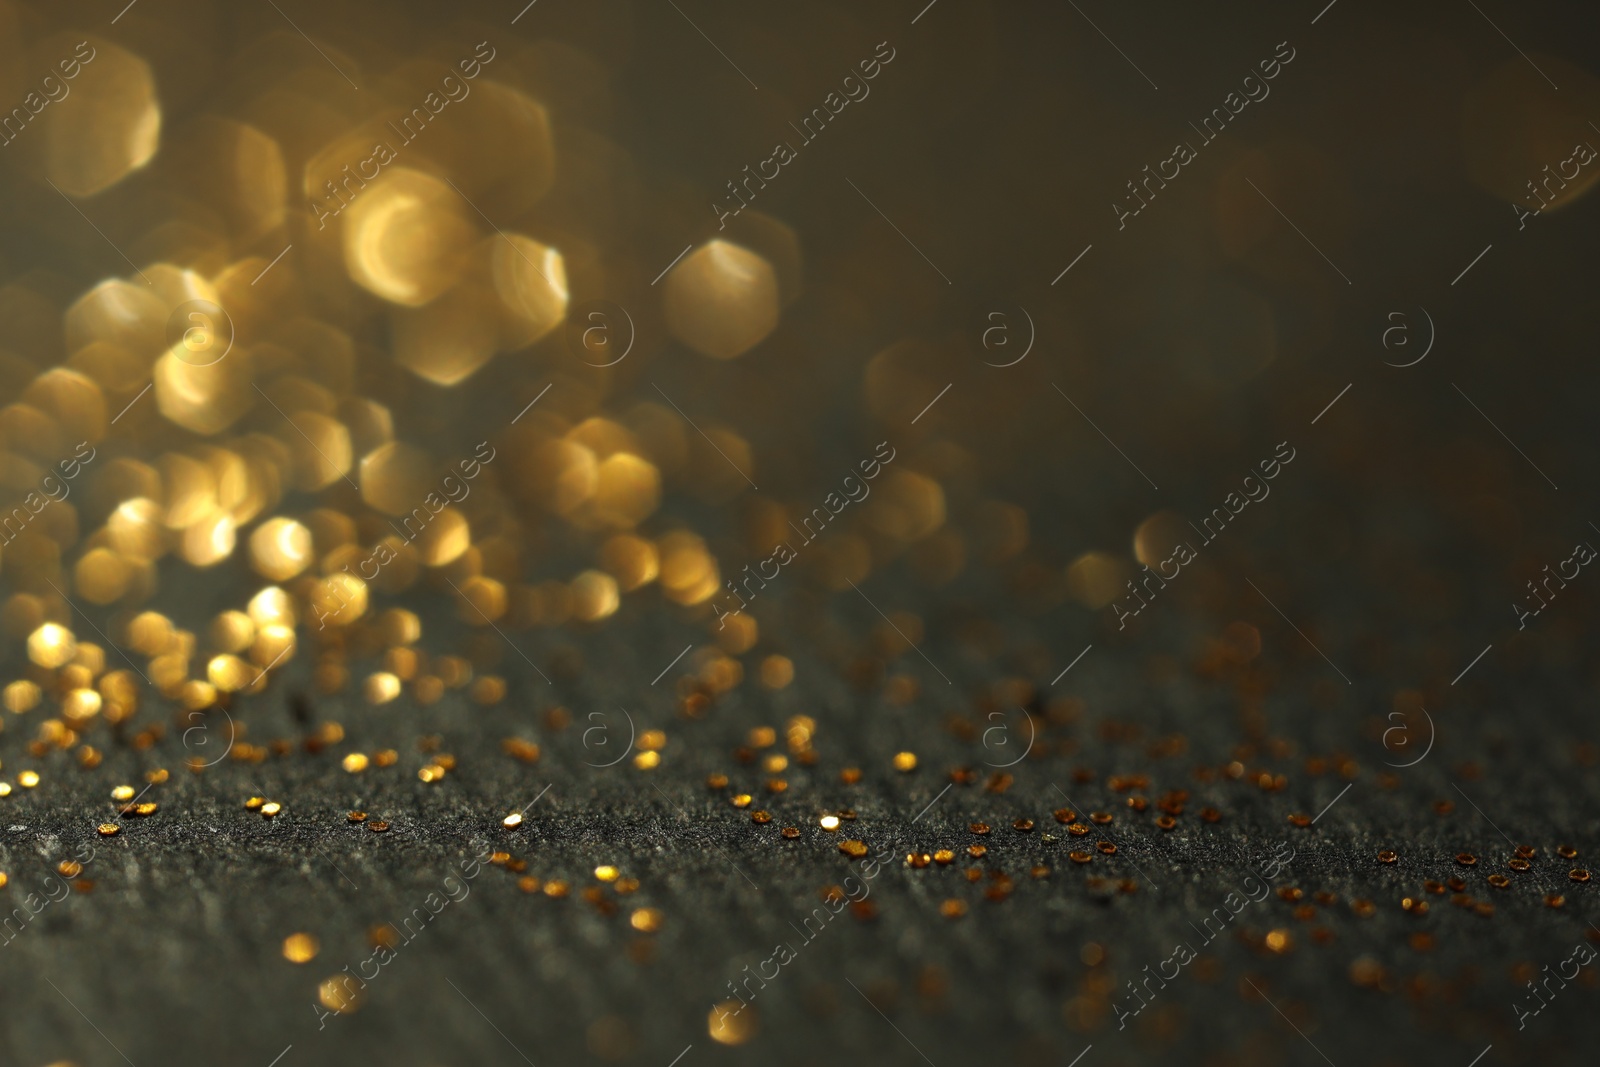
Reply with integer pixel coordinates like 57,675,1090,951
662,240,778,360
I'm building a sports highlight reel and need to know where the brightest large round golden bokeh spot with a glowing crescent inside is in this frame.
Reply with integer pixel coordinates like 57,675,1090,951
344,166,477,307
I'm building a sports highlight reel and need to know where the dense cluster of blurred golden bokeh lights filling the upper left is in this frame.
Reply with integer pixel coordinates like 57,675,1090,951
0,0,972,753
